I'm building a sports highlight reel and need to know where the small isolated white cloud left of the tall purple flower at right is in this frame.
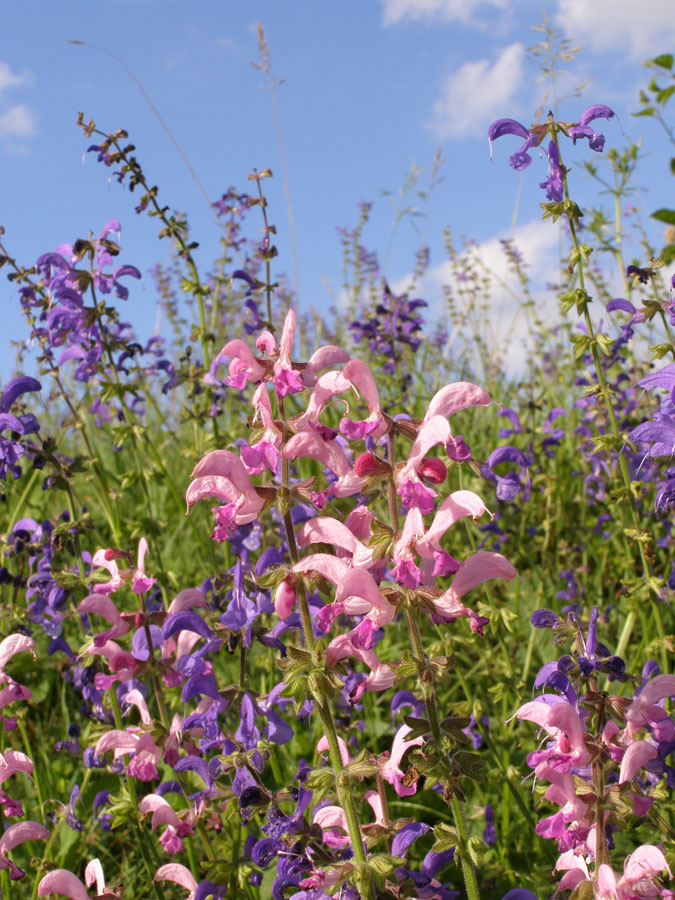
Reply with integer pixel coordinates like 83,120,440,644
427,42,525,141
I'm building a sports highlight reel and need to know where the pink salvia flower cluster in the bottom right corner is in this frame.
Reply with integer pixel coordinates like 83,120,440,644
516,675,675,900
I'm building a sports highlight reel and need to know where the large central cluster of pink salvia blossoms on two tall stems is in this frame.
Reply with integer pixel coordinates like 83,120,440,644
186,310,515,702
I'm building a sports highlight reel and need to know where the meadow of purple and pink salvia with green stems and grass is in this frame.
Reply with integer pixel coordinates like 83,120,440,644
0,17,675,900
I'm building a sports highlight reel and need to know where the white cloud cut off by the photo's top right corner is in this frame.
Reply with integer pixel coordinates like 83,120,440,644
556,0,675,58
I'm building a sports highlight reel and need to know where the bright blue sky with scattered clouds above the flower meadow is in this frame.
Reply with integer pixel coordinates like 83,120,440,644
0,0,675,376
